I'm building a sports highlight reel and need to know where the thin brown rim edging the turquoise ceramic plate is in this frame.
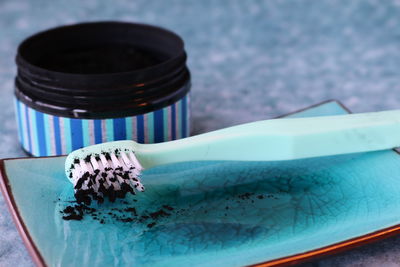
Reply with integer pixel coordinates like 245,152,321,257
0,99,400,267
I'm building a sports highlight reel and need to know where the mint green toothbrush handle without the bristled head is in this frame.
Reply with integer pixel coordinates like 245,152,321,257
135,110,400,168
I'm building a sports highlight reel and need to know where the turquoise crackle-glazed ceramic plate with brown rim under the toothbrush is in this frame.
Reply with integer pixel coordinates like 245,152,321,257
1,102,400,266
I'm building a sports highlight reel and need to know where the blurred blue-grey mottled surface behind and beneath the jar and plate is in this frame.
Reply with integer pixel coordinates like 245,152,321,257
0,0,400,266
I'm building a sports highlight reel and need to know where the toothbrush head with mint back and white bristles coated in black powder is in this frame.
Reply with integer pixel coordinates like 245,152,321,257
65,141,144,205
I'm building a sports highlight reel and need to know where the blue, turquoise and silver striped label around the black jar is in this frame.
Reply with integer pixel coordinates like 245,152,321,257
15,94,190,156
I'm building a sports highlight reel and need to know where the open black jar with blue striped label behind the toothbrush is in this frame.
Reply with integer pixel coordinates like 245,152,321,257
15,22,190,156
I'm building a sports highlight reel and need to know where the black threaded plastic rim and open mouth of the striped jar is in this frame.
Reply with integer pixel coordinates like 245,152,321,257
16,22,190,119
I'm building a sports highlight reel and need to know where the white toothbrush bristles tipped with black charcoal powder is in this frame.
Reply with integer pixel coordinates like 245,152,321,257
71,151,144,204
